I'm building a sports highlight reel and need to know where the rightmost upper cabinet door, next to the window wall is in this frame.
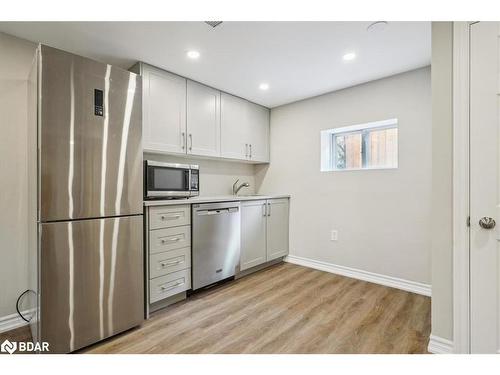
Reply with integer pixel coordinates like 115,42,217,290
248,103,269,162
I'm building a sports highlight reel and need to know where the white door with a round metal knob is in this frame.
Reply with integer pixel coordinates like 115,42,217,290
470,22,500,353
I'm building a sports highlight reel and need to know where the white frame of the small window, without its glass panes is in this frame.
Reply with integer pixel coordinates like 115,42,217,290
320,118,399,172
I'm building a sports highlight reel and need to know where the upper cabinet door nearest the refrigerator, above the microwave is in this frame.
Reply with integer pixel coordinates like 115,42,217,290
143,66,186,153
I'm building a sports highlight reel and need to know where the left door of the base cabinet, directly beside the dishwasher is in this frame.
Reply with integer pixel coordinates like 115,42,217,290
240,201,266,271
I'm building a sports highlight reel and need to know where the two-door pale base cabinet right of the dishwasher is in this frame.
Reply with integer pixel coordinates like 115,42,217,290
240,198,288,271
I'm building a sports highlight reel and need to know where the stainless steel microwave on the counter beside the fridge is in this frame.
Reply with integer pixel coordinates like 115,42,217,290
144,160,200,199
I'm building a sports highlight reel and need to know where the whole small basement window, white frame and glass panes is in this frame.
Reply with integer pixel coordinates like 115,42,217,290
321,119,398,171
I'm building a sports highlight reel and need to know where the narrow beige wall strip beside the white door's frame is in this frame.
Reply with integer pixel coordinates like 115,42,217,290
431,22,453,340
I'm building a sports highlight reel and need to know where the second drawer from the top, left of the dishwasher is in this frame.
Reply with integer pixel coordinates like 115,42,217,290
149,225,191,254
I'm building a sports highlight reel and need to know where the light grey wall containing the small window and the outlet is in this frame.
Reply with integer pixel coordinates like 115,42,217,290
256,67,432,284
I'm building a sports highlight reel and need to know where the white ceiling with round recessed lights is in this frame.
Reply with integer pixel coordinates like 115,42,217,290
0,22,431,107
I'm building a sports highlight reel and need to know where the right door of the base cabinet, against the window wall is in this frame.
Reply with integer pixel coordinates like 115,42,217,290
267,198,288,261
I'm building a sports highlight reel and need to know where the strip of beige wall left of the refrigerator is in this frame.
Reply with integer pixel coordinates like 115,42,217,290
0,33,36,323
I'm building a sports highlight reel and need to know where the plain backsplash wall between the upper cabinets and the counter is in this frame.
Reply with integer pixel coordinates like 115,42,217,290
144,153,255,196
